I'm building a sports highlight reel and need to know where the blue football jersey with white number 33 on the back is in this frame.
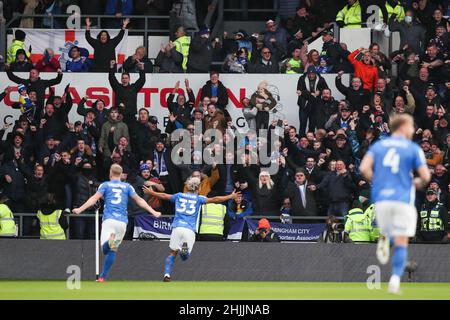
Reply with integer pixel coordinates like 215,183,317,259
170,192,207,232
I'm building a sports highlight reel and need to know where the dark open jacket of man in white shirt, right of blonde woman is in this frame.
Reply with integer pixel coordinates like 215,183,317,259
283,182,317,216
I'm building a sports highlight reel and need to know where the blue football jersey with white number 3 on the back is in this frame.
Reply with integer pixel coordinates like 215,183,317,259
98,180,136,223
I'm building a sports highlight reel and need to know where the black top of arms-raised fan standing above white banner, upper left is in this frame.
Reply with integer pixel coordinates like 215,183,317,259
86,29,125,72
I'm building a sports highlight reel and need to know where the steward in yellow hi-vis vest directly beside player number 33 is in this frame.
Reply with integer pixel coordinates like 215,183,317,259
198,203,230,241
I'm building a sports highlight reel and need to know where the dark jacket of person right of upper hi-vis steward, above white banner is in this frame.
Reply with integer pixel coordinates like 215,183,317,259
187,35,213,73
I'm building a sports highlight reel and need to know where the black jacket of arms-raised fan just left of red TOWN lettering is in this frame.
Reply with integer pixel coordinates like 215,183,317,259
109,68,145,116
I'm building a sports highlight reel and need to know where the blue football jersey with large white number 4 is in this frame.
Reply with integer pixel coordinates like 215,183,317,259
368,137,426,205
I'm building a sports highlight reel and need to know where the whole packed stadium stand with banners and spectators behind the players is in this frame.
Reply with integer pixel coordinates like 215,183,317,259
0,0,450,243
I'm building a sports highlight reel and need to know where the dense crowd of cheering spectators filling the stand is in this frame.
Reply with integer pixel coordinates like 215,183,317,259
0,1,450,238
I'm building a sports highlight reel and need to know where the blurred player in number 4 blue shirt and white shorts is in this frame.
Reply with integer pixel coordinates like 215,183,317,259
360,114,431,294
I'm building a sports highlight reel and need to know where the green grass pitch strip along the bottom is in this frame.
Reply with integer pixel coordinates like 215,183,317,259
0,281,450,300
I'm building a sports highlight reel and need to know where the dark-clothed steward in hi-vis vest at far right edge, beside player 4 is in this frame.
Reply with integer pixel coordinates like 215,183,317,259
417,189,449,242
